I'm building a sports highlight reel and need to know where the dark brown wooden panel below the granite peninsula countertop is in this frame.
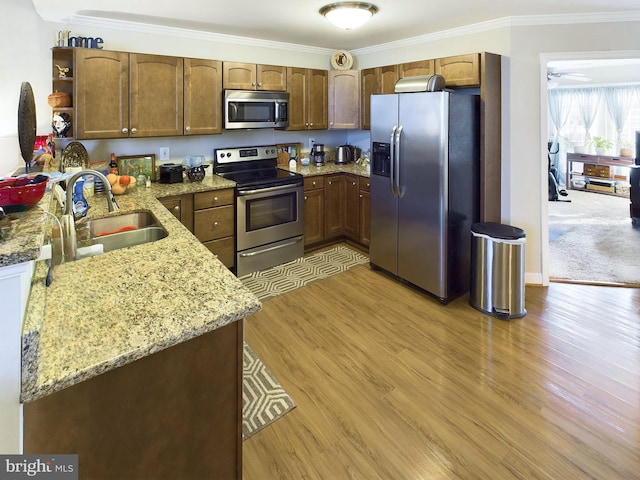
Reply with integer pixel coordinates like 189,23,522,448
23,318,244,479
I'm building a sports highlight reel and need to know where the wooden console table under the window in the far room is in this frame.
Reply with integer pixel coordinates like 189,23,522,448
566,153,635,197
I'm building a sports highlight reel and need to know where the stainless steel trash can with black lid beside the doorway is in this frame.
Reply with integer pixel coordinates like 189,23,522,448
469,222,527,319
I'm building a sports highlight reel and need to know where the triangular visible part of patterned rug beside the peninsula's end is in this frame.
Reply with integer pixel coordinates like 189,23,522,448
242,342,296,440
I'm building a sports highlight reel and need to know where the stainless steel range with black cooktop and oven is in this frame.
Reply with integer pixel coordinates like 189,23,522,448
213,145,304,277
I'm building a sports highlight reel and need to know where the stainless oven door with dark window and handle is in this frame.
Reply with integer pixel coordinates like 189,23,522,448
236,183,304,252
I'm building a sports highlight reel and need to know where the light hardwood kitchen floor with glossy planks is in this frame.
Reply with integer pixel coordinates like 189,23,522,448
243,266,640,480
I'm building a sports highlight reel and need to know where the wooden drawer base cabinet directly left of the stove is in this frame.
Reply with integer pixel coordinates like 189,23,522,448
193,188,236,268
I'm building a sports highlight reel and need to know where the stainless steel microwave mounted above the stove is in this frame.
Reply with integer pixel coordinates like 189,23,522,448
224,90,289,130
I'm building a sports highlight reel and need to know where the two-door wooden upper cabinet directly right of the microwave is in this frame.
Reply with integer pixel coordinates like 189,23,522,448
287,67,329,130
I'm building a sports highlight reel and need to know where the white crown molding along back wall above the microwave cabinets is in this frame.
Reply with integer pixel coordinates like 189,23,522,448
65,15,335,55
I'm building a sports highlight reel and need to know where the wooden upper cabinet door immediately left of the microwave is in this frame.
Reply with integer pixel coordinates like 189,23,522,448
184,58,222,135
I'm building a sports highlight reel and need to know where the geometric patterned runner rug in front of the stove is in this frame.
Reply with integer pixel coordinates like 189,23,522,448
240,245,369,300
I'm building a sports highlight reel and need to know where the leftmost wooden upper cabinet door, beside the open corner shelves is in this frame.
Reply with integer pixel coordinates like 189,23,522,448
74,48,129,140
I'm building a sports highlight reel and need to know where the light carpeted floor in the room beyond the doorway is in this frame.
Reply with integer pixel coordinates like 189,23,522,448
549,190,640,286
